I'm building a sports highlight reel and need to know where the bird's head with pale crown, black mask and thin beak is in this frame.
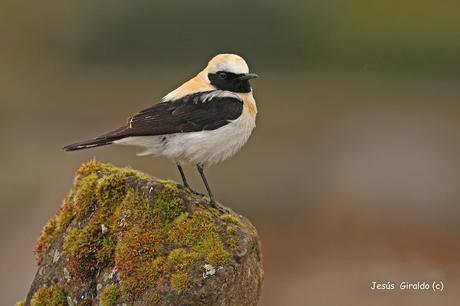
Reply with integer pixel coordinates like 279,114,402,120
204,54,258,92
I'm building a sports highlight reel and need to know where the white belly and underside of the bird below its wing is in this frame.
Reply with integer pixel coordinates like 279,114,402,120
115,113,255,165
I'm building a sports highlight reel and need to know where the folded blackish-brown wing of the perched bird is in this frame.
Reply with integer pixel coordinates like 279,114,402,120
98,91,243,140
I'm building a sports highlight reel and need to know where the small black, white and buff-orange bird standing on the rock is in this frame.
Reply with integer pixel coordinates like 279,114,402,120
63,54,258,208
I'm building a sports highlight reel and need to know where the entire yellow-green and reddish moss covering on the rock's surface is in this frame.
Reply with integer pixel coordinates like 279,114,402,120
32,161,248,305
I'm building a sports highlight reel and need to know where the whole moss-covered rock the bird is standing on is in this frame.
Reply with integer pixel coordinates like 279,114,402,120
25,161,263,306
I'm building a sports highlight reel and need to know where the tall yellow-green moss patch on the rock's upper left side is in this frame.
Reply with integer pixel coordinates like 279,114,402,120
63,161,131,279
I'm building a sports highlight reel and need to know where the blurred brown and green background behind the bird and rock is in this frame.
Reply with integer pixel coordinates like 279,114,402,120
0,0,460,306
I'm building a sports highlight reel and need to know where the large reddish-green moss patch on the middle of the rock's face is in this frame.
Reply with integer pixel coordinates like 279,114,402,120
115,192,230,297
